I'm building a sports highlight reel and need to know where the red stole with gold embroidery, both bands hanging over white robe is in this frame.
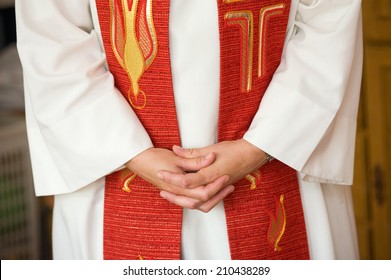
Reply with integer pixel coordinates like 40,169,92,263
96,0,309,259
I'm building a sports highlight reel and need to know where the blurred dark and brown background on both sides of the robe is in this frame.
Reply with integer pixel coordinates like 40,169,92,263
0,0,391,260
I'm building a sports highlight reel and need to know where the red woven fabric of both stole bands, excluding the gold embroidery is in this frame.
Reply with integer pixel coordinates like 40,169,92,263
97,0,309,259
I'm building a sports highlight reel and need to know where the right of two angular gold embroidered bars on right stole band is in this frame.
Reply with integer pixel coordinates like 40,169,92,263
258,4,285,77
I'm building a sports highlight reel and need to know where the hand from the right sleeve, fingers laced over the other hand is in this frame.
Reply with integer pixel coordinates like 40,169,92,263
158,139,266,212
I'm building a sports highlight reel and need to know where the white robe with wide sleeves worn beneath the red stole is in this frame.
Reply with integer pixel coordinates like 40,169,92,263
16,0,362,259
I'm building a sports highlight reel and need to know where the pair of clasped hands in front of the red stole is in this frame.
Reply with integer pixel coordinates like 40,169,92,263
126,139,266,212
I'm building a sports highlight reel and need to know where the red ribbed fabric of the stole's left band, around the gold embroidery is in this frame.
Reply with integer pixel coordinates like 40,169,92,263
96,0,182,259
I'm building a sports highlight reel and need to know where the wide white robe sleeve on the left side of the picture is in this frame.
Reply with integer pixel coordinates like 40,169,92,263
15,0,152,195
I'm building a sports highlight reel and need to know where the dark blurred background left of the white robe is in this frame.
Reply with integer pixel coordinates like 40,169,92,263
0,0,52,259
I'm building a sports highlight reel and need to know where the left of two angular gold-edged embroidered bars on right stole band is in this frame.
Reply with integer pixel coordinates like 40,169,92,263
224,11,254,92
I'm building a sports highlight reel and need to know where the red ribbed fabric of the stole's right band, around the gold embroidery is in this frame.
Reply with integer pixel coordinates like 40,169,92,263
218,0,309,259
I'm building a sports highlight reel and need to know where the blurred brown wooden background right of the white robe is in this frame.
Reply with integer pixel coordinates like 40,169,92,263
353,0,391,260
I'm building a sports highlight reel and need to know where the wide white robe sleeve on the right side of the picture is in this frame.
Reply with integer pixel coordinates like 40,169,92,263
244,0,362,184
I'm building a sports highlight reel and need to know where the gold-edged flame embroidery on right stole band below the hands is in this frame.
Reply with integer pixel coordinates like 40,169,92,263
268,194,286,251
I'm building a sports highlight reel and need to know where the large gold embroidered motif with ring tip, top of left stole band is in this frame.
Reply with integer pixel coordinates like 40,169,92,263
110,0,158,109
